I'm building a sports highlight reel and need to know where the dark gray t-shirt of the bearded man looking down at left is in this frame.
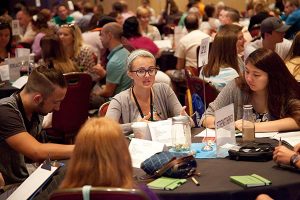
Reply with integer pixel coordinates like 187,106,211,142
0,94,42,184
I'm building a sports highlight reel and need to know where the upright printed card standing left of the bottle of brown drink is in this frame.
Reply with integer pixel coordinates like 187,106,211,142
215,104,236,158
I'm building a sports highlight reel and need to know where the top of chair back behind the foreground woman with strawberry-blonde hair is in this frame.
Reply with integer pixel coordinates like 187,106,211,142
50,187,148,200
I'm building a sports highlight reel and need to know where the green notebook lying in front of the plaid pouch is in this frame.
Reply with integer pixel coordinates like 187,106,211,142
147,177,186,190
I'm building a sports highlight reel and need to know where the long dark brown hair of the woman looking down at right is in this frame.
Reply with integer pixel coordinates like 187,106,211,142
242,48,300,125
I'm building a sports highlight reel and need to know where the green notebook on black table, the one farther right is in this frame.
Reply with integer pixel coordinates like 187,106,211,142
230,174,272,187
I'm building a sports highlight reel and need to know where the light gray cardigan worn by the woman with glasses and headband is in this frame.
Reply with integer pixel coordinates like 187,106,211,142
105,83,182,134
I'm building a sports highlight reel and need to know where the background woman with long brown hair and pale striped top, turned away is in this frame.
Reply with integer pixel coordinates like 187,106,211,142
199,24,245,90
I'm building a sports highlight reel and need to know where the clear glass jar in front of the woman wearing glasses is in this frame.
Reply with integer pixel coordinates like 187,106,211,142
172,115,191,151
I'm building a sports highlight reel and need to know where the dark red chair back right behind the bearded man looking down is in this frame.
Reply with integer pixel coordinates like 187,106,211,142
46,72,92,143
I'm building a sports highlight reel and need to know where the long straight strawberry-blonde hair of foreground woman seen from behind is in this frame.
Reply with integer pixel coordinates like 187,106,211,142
60,118,134,188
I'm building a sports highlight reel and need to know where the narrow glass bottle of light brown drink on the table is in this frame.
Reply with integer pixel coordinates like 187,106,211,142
242,105,255,142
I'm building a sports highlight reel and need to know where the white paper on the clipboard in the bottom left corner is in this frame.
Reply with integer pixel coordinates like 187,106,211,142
8,165,57,200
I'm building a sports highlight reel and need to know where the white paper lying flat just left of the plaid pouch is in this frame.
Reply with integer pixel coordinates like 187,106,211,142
129,138,166,168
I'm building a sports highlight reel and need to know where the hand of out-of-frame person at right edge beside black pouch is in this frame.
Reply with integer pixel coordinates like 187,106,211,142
273,145,296,165
